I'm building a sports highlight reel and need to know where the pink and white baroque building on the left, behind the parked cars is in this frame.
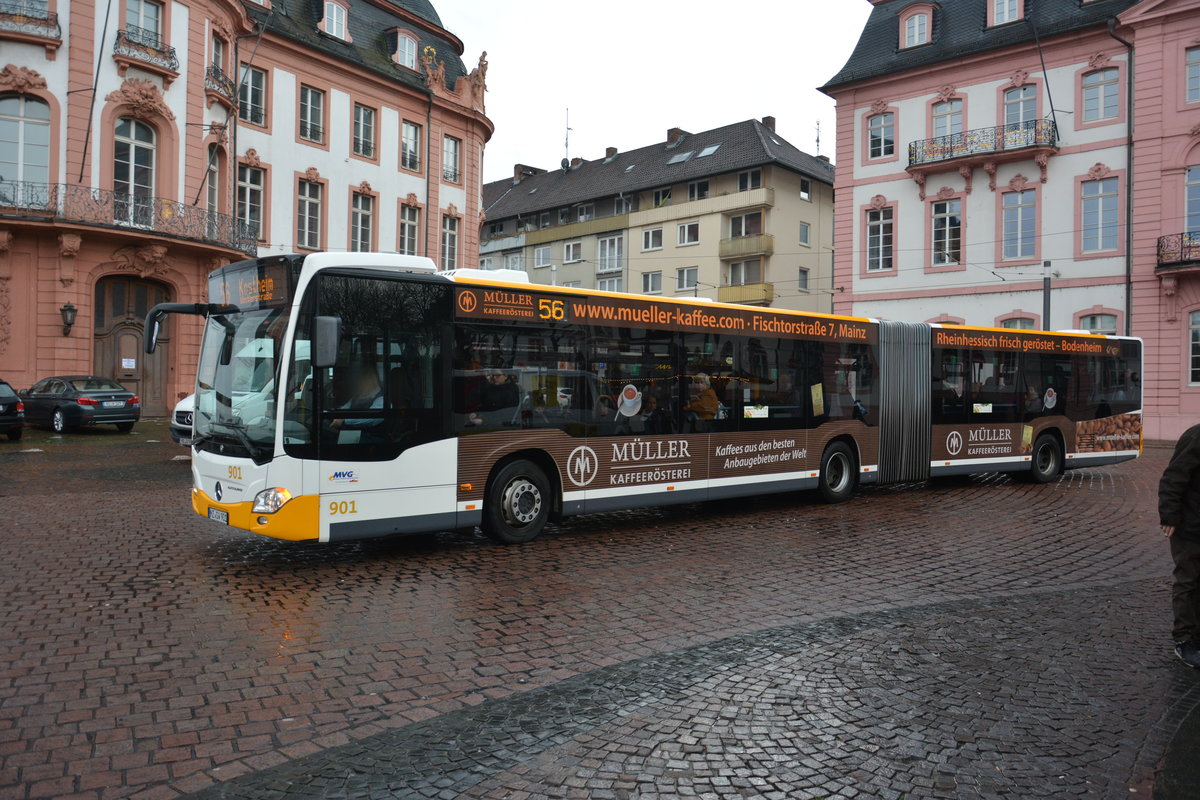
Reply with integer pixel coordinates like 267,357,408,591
0,0,492,414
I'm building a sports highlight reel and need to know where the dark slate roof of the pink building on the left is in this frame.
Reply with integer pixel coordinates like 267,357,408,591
244,0,467,94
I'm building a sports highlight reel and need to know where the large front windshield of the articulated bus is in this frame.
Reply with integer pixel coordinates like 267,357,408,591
194,308,288,463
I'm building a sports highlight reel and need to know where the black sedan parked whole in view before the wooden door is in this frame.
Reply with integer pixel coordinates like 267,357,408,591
22,375,142,433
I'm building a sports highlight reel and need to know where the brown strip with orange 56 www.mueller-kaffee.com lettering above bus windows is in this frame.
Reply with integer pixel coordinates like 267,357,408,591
455,287,878,344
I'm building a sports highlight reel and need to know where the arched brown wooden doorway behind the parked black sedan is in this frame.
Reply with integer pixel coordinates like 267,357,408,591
92,275,169,416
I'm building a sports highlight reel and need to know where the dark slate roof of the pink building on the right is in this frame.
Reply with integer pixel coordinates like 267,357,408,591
821,0,1140,92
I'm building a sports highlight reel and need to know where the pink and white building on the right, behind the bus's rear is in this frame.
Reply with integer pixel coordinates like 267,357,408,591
823,0,1200,439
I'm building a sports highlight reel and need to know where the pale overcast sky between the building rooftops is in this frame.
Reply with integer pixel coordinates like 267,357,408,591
433,0,871,182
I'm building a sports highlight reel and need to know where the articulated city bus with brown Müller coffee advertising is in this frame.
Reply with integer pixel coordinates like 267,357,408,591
146,253,1141,542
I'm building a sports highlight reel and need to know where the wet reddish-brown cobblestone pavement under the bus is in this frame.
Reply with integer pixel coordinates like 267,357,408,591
0,422,1200,800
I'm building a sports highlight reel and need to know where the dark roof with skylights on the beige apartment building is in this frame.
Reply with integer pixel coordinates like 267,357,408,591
484,120,834,221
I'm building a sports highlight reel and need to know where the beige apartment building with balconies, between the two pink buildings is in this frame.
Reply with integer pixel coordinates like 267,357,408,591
480,116,834,312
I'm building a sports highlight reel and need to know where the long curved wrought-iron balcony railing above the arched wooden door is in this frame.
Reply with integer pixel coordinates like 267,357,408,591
0,181,258,255
